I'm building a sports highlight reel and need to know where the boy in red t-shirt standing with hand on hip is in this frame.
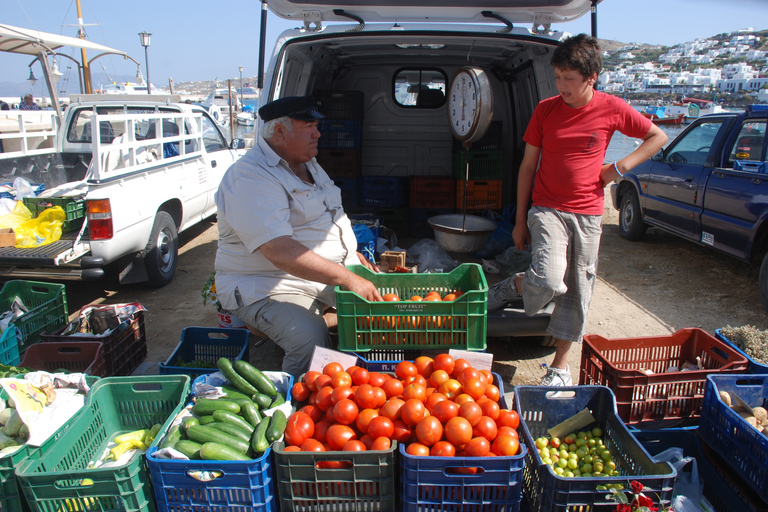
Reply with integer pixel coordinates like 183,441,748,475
488,34,667,386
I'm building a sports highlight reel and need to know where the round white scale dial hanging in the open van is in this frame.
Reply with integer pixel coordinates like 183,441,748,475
446,66,493,142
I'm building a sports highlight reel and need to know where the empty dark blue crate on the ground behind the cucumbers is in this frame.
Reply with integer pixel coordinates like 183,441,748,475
158,327,250,376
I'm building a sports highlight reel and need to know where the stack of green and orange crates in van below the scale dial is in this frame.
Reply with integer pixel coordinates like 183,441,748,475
452,121,504,210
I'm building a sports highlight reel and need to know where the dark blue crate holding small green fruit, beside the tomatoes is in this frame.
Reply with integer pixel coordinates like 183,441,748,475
514,386,677,512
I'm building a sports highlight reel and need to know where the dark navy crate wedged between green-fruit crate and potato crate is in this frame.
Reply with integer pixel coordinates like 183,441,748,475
632,429,766,512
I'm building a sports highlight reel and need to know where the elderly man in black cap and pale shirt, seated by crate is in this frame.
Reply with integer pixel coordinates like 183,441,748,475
216,96,382,377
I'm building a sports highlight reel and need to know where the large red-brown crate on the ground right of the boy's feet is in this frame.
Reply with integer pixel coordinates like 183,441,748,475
579,328,747,426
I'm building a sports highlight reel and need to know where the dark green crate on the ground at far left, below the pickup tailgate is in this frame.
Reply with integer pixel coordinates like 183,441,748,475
0,280,69,354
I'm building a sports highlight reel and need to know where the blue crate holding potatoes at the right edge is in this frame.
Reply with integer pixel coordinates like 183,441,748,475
699,374,768,502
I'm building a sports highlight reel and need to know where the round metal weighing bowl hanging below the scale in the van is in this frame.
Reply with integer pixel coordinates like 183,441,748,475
427,213,496,253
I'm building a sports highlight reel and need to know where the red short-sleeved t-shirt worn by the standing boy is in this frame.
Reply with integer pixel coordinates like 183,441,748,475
523,91,651,215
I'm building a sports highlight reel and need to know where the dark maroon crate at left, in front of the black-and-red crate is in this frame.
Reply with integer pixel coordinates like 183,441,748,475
19,341,106,377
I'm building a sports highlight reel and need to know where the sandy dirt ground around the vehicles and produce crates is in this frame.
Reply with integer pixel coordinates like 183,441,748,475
61,189,768,389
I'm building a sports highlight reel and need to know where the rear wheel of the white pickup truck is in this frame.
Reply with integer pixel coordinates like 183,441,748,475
144,212,179,288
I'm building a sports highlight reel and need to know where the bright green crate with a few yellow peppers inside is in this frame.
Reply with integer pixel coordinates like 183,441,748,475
16,375,190,512
